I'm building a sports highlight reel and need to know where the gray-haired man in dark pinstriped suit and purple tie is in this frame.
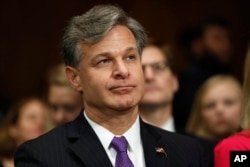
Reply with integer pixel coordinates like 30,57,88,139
15,5,202,167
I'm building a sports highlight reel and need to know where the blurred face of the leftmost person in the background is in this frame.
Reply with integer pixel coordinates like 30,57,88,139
11,100,49,145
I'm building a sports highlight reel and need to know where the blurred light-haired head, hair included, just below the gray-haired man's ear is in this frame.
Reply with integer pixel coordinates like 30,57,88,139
48,64,83,126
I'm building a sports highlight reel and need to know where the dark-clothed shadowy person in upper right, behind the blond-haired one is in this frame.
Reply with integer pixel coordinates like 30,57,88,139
174,18,232,132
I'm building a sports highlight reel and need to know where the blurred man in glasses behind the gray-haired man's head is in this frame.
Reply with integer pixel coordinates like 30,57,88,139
139,39,179,132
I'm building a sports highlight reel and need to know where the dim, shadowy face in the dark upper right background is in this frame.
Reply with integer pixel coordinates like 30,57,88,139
203,25,231,62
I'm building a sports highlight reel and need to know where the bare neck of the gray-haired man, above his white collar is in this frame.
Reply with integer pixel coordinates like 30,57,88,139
85,106,138,135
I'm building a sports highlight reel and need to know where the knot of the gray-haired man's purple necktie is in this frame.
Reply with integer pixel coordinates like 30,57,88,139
111,136,128,152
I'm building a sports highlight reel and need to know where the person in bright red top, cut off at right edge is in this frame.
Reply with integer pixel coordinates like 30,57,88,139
214,43,250,167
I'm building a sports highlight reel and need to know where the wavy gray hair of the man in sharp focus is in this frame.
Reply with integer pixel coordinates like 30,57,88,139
62,5,147,67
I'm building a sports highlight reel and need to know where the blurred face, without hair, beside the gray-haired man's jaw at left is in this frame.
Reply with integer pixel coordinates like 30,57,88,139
48,85,83,125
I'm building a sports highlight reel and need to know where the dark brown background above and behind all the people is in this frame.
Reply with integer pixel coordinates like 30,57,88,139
0,0,250,110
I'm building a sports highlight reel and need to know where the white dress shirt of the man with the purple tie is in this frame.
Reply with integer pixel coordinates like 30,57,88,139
84,112,145,167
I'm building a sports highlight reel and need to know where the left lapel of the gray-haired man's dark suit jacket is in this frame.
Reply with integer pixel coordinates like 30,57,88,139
67,114,112,167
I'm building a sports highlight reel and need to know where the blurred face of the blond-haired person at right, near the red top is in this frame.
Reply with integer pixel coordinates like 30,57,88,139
201,80,242,138
